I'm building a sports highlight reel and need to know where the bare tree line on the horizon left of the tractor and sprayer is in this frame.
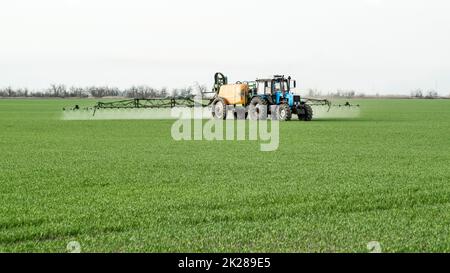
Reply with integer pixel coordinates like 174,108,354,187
0,84,207,98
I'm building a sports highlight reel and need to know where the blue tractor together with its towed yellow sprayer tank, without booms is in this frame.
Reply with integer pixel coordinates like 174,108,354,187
211,73,312,121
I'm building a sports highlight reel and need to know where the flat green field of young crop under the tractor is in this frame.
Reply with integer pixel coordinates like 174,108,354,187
0,99,450,252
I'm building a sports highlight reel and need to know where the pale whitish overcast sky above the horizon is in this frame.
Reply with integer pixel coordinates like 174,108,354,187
0,0,450,95
